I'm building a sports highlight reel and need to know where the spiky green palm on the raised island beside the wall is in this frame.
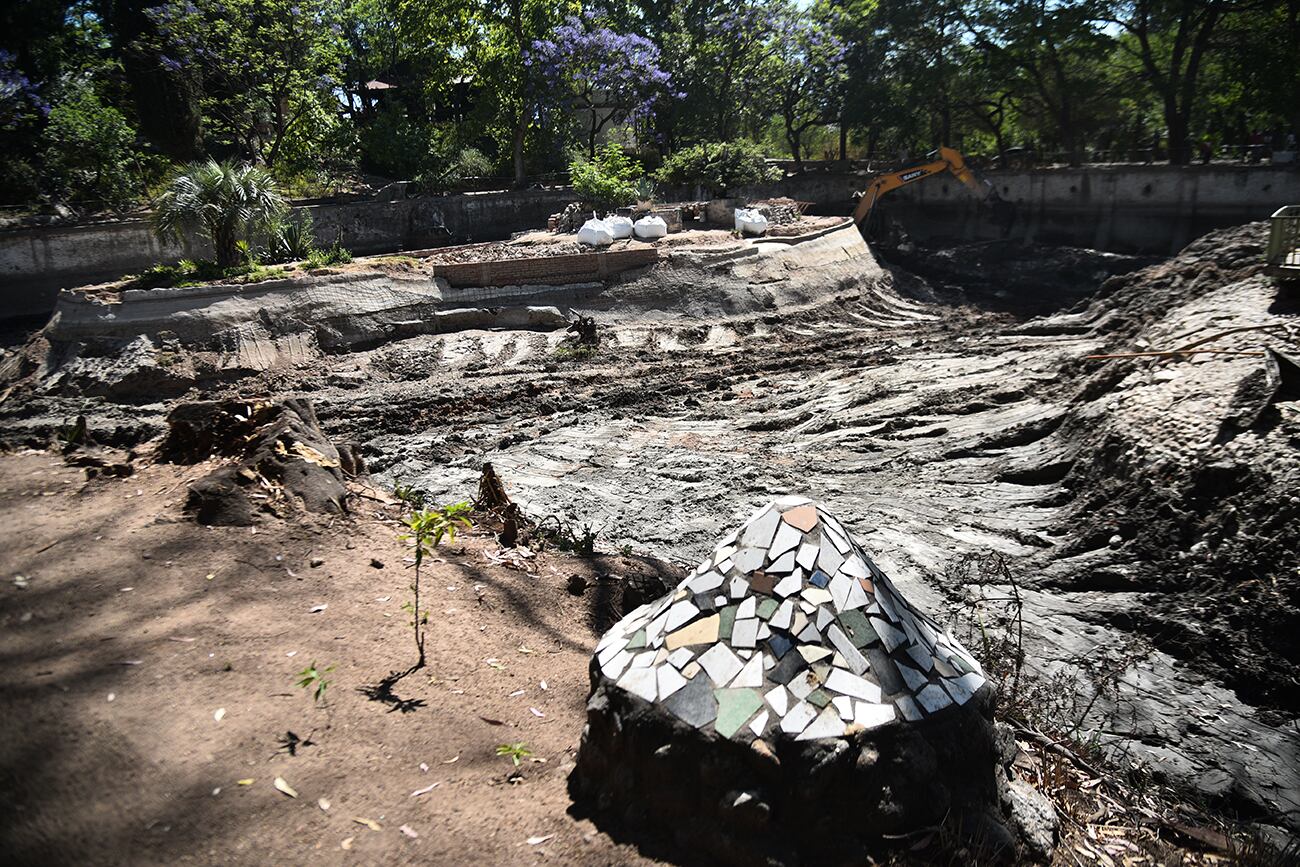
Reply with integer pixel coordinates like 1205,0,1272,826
153,160,287,268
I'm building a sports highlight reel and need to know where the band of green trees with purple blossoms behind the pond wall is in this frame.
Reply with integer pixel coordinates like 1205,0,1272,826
0,0,1300,211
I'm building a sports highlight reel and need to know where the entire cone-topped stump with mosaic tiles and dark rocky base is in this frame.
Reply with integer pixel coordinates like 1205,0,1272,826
571,498,1029,864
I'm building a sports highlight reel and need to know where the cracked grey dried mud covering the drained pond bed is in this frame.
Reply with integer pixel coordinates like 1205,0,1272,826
0,224,1300,829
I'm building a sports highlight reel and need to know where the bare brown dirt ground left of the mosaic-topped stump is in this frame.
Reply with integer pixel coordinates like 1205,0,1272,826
0,454,670,864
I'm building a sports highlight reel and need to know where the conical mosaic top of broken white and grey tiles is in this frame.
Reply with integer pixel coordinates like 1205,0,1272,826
595,497,985,741
